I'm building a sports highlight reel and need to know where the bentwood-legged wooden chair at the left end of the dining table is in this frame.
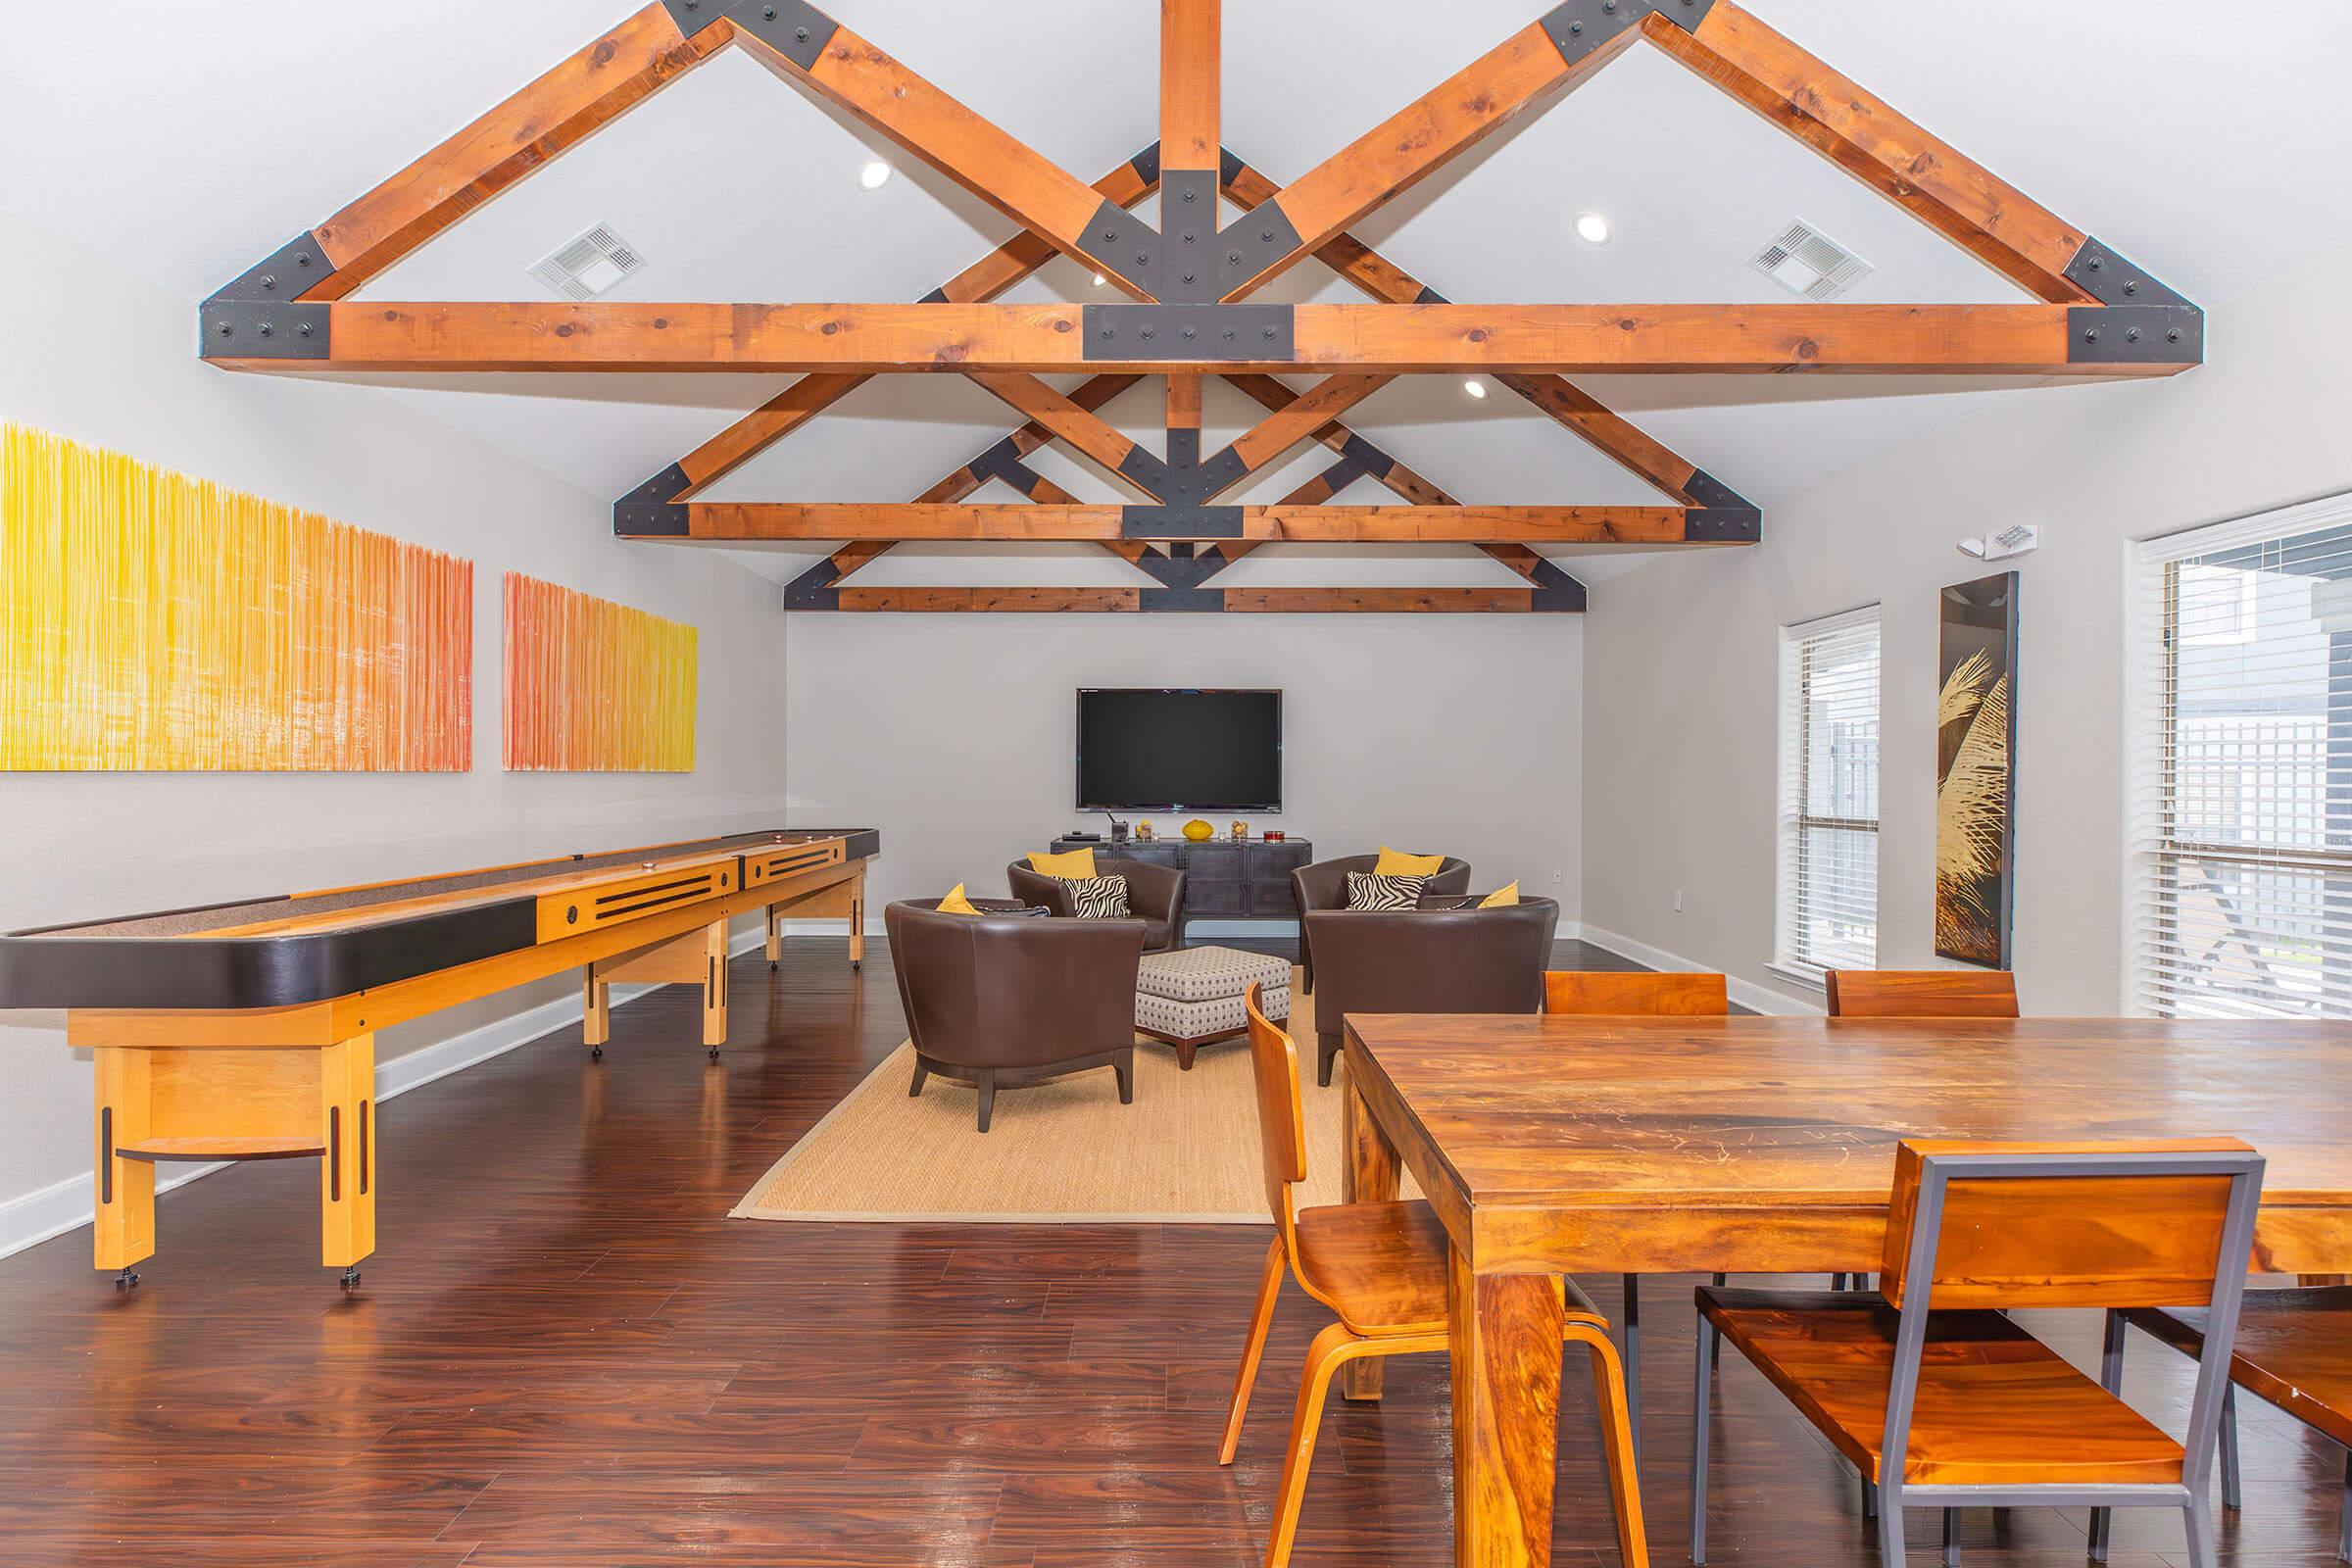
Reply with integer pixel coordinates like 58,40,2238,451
1216,985,1648,1568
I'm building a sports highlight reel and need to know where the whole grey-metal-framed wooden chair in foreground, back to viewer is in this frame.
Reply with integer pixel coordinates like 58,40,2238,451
1691,1138,2263,1568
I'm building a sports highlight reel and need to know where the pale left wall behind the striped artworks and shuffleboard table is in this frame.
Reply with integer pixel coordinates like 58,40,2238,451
0,212,783,1239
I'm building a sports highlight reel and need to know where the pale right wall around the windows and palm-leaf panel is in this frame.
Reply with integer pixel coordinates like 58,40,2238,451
1586,239,2352,1013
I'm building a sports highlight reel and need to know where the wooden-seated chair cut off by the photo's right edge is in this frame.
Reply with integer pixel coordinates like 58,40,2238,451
2091,1286,2352,1563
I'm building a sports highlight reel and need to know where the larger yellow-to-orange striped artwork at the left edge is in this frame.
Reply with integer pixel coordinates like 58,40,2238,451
0,425,472,773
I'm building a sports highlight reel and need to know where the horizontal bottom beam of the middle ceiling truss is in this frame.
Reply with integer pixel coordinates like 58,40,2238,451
640,510,1712,550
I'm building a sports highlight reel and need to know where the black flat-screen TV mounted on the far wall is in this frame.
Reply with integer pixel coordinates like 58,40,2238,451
1077,686,1282,811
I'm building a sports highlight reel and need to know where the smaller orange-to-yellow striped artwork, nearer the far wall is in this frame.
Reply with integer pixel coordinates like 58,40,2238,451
506,571,696,773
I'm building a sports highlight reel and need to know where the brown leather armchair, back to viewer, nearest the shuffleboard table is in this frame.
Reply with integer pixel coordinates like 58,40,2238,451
882,898,1143,1133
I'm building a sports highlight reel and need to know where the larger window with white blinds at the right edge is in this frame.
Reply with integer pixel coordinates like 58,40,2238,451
2131,499,2352,1018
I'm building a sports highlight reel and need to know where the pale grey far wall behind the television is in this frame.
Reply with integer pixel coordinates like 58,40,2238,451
786,613,1583,924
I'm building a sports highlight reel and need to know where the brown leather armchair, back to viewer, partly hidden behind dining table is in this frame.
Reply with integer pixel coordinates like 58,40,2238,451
1300,898,1559,1084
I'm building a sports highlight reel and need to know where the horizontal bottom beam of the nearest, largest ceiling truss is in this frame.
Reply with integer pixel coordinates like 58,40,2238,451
207,301,2204,376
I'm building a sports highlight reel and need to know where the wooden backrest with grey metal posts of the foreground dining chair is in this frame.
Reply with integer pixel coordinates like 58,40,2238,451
1880,1138,2263,1486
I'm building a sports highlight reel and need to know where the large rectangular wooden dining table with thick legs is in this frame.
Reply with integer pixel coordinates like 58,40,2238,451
1346,1013,2352,1568
